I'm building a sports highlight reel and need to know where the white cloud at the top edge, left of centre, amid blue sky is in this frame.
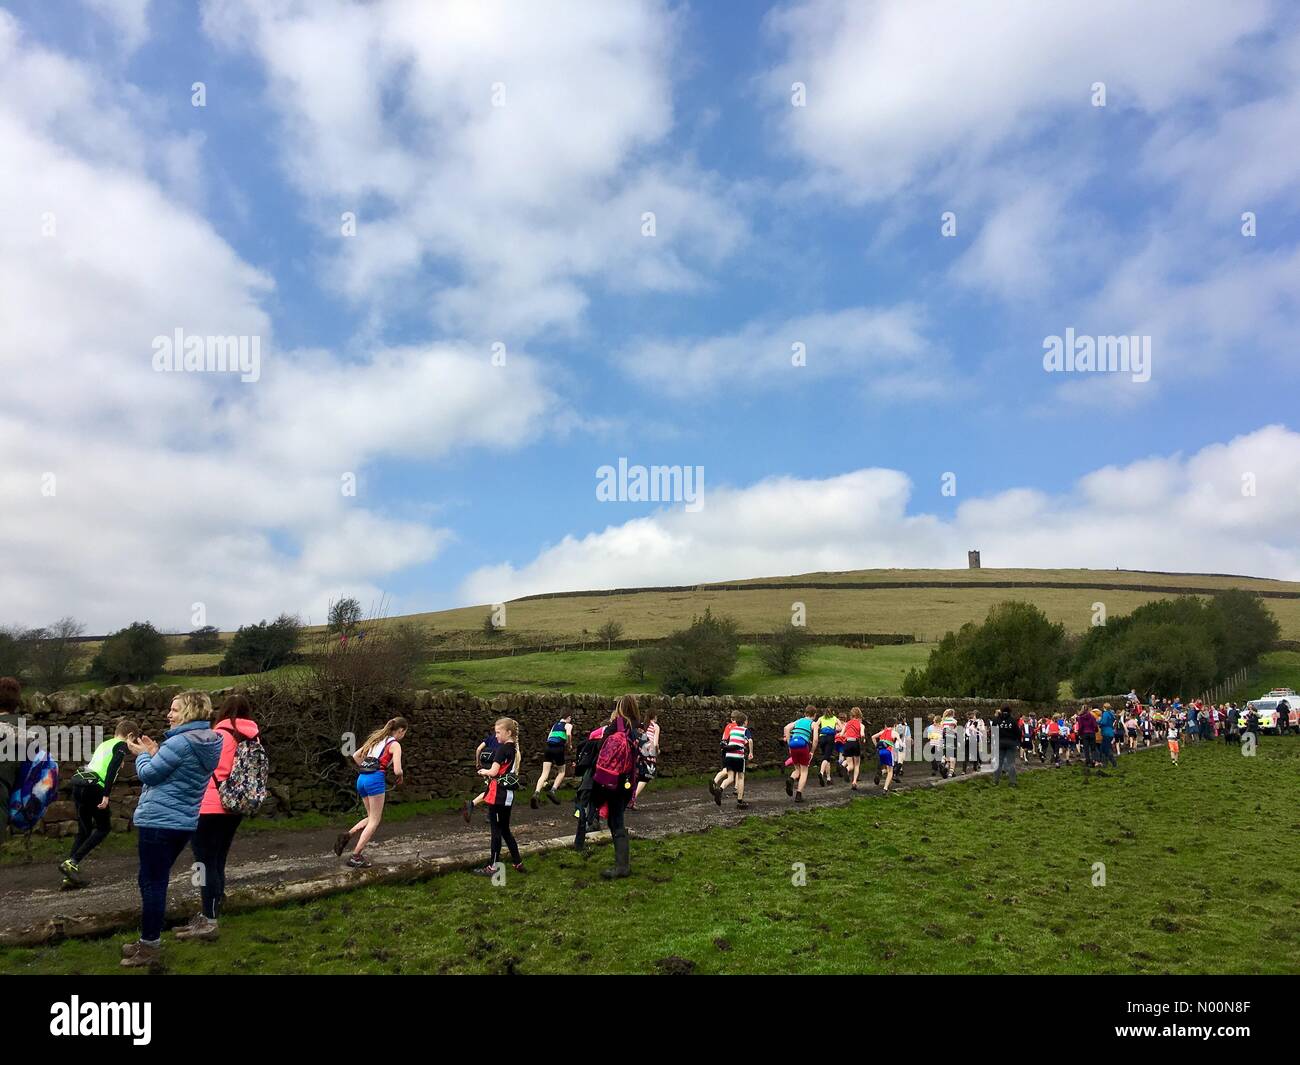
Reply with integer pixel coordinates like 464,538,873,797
204,0,745,338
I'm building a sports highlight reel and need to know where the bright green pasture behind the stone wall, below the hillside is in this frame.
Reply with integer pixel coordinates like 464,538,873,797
416,644,931,697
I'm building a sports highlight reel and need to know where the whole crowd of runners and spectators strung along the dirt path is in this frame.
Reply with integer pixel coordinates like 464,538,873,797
0,677,1300,967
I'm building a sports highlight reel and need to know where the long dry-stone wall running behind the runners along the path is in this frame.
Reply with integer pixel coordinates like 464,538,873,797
10,685,1122,836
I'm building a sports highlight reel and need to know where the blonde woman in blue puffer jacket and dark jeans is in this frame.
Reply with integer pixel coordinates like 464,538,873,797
122,692,221,969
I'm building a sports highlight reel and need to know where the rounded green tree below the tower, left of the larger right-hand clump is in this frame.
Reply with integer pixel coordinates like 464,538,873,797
902,601,1067,702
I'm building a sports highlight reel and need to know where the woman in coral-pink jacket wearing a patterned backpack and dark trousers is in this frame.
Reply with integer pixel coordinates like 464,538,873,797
176,696,267,939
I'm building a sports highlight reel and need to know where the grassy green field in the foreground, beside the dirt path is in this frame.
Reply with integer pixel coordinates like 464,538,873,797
0,737,1300,974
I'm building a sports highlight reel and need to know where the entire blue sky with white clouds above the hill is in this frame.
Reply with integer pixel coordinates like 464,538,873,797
0,0,1300,631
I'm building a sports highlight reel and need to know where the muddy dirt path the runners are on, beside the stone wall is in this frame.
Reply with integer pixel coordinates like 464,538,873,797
0,763,1138,945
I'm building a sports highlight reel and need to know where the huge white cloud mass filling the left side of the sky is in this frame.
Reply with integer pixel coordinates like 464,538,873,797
0,12,556,632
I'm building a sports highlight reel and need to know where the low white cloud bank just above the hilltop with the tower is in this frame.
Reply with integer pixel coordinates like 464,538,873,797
460,425,1300,603
